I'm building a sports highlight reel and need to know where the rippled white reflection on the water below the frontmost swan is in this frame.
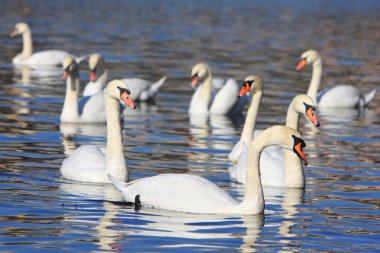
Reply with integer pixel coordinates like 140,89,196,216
67,202,264,252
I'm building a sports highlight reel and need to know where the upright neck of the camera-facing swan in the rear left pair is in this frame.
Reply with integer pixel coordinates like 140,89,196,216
60,70,80,122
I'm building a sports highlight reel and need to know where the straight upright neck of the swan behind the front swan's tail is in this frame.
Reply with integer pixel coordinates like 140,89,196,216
105,95,128,182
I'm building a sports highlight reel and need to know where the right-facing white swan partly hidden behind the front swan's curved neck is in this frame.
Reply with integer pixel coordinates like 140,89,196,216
229,91,319,188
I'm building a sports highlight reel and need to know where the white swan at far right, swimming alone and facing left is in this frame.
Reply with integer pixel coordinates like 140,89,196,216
296,50,376,108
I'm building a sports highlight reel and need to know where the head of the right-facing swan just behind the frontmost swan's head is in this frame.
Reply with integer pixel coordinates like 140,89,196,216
291,94,319,127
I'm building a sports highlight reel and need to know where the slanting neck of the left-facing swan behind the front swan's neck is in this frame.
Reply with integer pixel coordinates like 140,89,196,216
240,90,263,147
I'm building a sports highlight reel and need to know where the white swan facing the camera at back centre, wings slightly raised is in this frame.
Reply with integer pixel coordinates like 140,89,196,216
189,62,249,115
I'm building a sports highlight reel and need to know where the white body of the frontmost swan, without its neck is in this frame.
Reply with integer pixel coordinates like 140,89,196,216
109,174,237,213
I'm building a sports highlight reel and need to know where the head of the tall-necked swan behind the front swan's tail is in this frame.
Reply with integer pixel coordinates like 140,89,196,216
105,79,136,109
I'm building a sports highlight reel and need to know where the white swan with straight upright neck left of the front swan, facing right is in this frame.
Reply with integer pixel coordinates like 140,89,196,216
61,80,135,183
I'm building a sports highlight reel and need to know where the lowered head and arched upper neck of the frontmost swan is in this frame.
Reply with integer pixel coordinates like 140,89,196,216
255,125,308,165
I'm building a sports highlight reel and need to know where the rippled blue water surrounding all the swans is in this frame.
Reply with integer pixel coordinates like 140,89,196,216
0,0,380,252
